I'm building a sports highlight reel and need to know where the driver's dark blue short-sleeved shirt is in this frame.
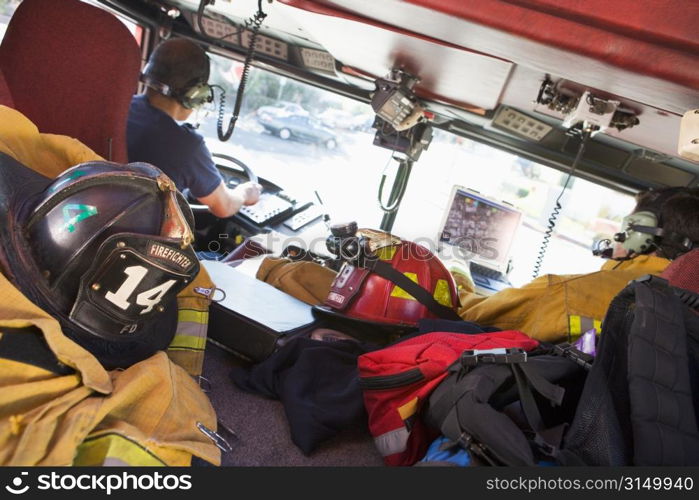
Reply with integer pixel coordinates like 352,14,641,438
126,94,221,198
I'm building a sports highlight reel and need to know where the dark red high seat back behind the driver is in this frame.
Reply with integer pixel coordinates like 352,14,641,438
0,0,141,162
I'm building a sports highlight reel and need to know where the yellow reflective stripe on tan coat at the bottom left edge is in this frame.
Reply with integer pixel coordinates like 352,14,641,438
73,434,166,466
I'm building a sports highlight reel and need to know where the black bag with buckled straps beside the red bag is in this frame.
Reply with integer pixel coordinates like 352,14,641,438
424,344,591,466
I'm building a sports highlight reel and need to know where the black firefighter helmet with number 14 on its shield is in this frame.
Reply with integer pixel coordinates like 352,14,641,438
0,155,199,368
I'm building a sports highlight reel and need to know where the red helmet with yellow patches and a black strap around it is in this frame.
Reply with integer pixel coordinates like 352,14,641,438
316,234,459,331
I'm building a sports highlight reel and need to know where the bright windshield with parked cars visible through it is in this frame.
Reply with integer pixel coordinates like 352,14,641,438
194,55,634,286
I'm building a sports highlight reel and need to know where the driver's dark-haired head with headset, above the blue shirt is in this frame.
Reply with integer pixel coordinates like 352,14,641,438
140,38,213,109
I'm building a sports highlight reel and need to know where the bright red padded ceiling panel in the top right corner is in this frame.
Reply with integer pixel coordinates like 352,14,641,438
404,0,699,89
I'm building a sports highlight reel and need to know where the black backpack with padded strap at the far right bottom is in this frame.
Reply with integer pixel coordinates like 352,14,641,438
559,276,699,466
